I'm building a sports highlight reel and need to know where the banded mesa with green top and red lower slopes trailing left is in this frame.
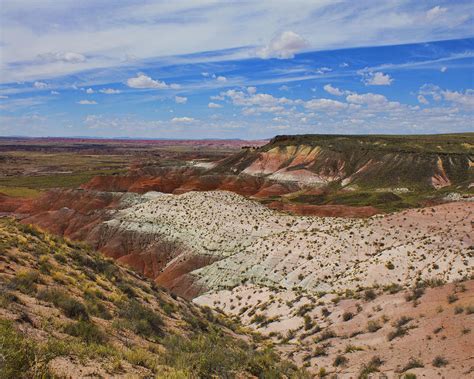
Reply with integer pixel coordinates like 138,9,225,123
83,134,474,217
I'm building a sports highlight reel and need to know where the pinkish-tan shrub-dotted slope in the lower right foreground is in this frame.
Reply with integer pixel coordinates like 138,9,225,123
194,280,474,378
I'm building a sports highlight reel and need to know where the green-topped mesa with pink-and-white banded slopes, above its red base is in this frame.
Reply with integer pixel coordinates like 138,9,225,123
216,134,474,189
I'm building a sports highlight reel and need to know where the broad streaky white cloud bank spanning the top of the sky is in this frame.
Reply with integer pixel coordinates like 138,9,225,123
0,0,472,85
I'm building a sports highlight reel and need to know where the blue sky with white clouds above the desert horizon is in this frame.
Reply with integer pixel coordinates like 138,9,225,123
0,0,474,139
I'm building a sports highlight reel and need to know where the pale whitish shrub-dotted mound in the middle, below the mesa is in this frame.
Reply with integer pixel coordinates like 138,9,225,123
110,191,474,292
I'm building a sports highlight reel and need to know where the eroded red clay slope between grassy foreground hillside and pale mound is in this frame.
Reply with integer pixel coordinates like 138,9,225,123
0,190,213,298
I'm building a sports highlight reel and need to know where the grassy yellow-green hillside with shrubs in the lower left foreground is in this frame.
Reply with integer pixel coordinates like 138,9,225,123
0,219,305,379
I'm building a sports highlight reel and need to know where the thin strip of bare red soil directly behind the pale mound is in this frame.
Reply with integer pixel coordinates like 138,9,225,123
266,201,382,218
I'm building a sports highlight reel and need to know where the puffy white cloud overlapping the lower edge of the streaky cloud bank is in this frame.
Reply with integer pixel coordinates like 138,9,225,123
257,31,309,59
